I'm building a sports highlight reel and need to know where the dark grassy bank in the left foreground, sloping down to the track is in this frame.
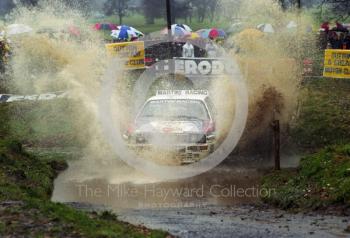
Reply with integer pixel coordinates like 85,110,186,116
0,140,167,237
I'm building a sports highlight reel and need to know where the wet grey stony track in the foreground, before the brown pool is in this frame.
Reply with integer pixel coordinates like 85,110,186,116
118,205,350,238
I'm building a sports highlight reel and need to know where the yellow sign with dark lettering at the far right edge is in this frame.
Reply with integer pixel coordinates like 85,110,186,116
323,50,350,78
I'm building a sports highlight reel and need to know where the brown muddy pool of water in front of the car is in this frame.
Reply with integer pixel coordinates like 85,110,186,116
52,162,265,208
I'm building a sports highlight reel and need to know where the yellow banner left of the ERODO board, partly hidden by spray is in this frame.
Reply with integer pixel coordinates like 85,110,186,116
106,41,145,69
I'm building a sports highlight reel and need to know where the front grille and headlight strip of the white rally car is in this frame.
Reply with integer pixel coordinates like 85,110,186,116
135,133,206,145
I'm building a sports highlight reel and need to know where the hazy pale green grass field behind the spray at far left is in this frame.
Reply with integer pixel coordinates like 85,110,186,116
0,99,91,147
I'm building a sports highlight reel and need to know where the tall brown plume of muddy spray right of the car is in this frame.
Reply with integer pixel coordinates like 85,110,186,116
222,0,316,161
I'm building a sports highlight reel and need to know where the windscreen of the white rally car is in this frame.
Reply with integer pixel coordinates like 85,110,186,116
138,99,209,121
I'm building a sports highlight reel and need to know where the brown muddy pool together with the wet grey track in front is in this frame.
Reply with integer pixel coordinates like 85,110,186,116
52,160,350,238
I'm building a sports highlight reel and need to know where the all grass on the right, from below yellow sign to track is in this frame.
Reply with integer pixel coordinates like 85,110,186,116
262,78,350,211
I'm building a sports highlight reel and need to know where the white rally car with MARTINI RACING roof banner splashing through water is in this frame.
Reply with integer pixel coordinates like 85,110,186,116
124,90,216,164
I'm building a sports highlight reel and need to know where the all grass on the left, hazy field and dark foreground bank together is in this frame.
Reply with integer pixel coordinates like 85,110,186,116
0,100,168,237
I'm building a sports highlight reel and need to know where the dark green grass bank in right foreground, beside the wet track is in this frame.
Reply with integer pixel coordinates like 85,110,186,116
262,144,350,209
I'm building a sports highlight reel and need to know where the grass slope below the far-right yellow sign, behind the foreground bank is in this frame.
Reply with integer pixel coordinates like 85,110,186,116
291,78,350,151
